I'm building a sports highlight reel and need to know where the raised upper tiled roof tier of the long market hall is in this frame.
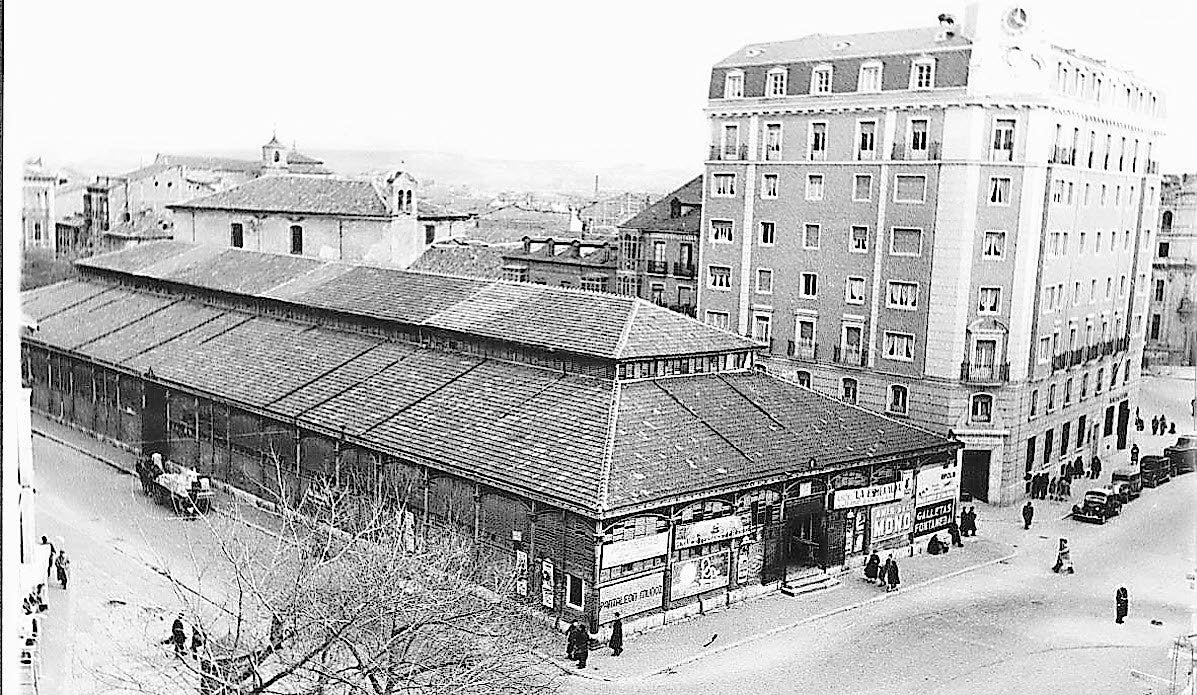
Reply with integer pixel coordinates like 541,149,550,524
77,242,754,359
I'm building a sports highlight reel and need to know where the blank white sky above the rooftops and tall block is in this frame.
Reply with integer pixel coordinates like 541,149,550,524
4,0,1197,171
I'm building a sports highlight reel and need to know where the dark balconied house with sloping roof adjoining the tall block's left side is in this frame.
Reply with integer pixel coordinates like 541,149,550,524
615,176,703,316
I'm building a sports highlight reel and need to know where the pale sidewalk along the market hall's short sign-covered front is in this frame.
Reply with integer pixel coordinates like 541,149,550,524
549,526,1021,681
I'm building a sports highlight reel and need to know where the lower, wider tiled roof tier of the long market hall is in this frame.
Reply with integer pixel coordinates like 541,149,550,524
23,277,953,518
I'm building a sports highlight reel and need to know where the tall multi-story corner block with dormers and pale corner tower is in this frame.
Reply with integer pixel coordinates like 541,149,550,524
699,4,1162,504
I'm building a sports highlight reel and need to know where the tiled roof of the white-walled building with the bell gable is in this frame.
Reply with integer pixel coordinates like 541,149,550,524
168,175,388,218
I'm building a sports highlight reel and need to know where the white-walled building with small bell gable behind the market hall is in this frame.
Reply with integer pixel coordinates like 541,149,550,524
168,171,426,268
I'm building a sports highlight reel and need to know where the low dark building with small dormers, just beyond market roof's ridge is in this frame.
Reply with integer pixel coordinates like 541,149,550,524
503,237,619,292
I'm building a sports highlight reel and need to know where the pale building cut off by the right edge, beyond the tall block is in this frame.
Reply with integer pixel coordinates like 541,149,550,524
1146,173,1197,365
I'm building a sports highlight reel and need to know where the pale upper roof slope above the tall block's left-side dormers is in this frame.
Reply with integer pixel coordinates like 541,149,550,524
715,26,972,68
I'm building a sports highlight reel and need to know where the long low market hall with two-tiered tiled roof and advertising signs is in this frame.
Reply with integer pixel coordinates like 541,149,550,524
22,242,959,629
